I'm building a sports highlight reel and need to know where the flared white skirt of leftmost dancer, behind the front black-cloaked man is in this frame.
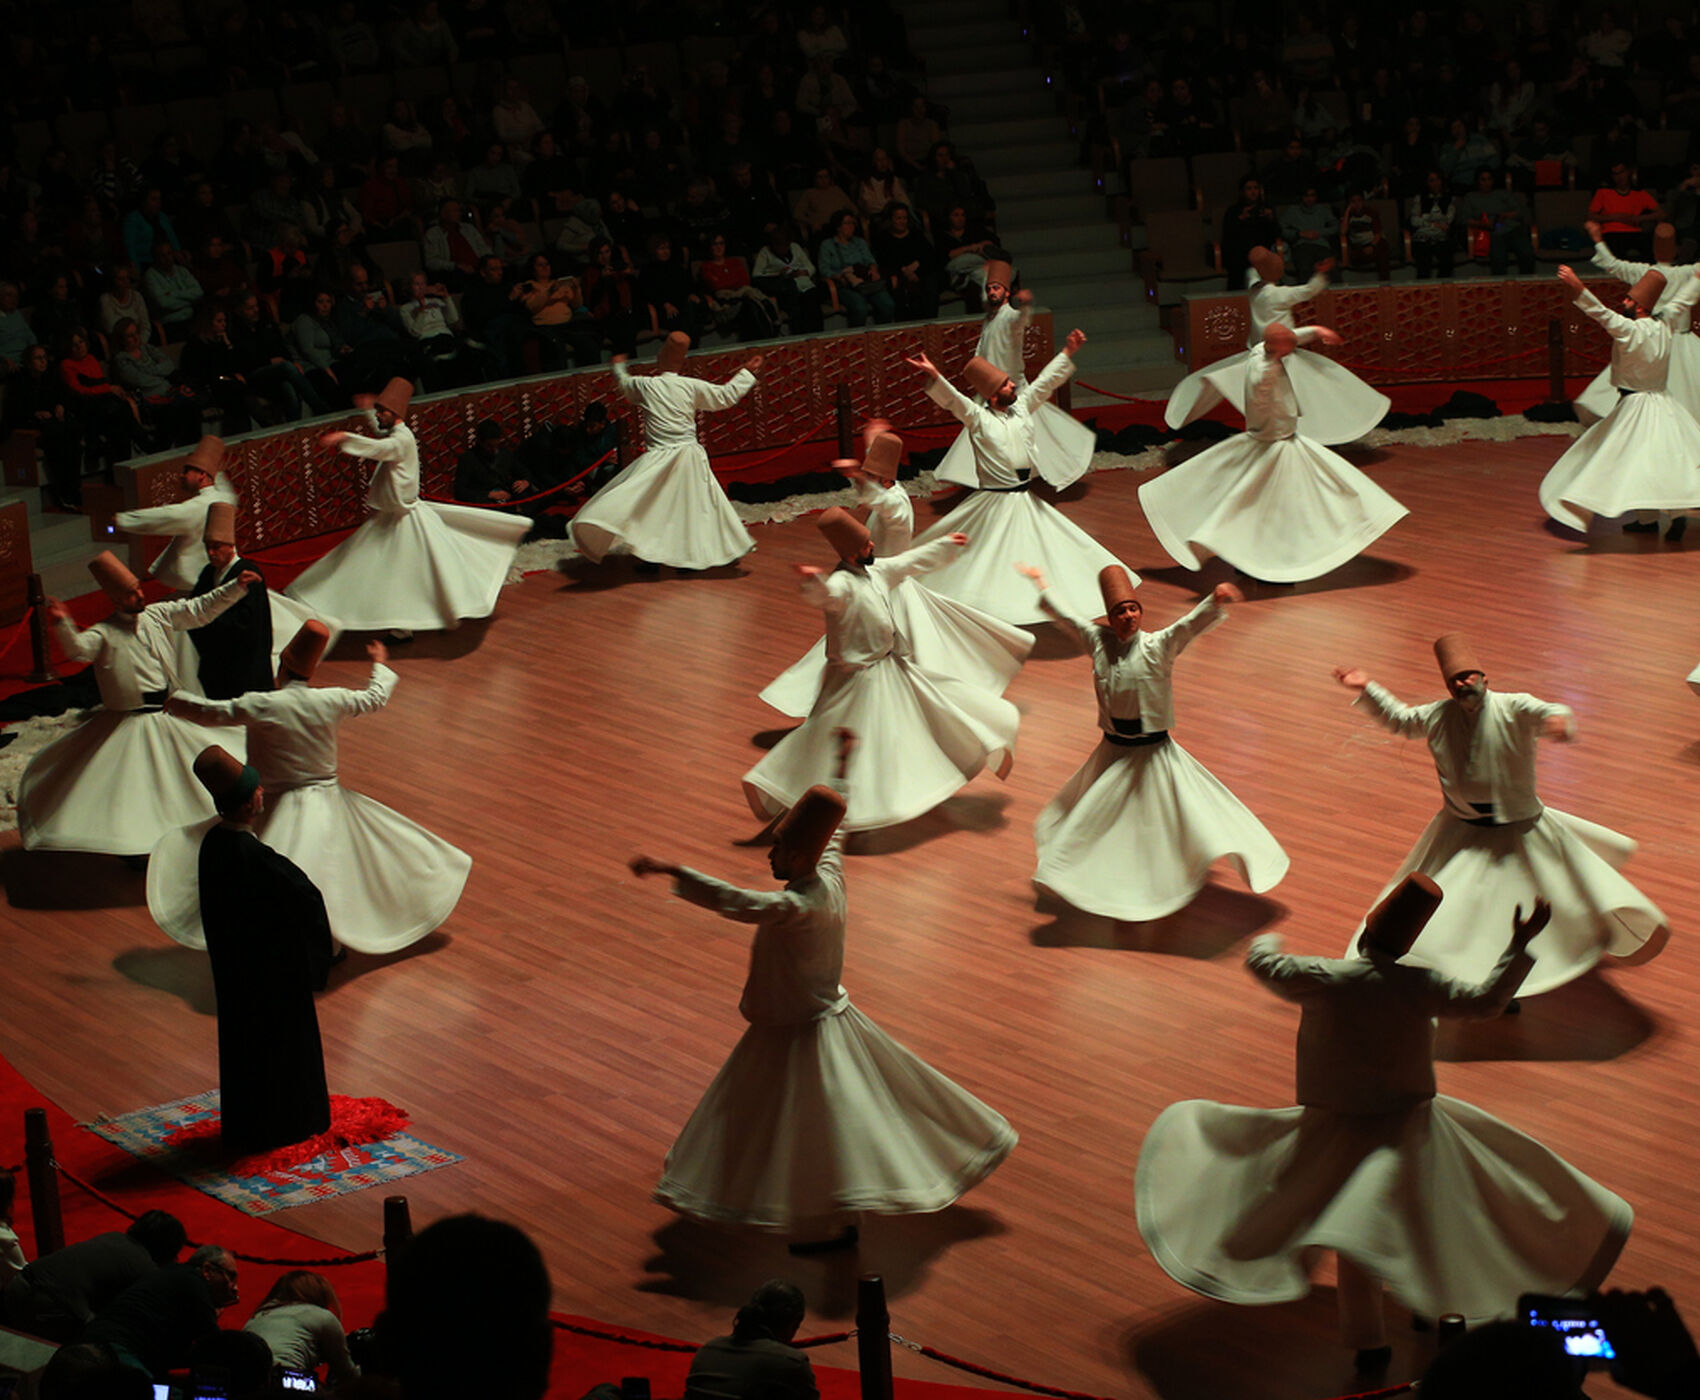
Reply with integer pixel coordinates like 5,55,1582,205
17,708,248,856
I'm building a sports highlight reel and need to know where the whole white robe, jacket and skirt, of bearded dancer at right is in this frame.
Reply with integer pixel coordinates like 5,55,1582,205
1346,681,1669,996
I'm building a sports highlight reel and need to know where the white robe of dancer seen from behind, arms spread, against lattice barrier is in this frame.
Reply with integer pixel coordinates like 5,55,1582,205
568,372,755,569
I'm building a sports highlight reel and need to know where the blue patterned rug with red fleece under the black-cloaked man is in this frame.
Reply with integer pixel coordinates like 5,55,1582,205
82,1089,464,1215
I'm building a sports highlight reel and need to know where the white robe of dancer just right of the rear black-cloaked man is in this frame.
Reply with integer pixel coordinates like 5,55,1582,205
284,418,530,641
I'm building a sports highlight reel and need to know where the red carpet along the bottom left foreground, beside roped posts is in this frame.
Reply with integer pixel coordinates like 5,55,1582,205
0,1057,1020,1400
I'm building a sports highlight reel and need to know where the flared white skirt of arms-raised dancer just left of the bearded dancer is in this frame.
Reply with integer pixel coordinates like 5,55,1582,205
1034,739,1289,921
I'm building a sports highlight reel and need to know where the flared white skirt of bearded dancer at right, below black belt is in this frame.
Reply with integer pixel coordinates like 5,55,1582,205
1345,807,1669,996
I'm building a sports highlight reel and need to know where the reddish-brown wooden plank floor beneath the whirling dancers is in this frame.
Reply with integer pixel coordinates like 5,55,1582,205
0,438,1700,1398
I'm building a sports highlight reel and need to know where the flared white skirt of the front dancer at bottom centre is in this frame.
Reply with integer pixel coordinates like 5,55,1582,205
655,1004,1015,1230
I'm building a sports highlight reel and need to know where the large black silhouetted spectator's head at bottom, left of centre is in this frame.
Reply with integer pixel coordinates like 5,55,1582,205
376,1215,554,1400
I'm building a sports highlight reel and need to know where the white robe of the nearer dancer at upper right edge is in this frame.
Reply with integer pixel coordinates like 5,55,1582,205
1540,287,1700,532
